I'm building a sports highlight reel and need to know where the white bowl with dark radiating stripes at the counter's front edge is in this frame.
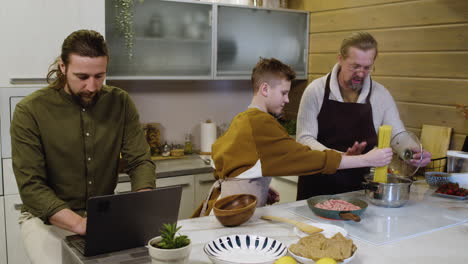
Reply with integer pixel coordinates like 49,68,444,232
203,235,288,264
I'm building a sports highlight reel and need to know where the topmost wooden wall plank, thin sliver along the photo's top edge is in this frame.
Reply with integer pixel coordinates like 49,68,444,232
289,0,408,12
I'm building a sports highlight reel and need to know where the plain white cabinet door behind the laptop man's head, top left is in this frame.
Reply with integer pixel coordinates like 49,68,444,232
0,0,105,87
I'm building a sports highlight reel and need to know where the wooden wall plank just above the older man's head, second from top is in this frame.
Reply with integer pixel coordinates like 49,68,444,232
310,0,468,33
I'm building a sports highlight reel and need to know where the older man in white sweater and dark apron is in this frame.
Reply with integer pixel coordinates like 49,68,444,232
297,32,431,200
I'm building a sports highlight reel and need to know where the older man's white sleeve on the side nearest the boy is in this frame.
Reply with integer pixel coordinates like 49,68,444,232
296,77,328,151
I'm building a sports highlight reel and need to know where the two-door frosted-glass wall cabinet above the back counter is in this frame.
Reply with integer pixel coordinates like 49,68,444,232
105,0,309,80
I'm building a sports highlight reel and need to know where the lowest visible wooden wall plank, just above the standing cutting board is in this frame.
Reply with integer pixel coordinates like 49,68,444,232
397,102,468,134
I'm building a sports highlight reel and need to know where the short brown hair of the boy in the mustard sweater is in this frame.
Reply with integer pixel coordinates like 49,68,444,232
252,57,296,93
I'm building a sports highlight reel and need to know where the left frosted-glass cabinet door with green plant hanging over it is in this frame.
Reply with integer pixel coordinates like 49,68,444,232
106,0,212,79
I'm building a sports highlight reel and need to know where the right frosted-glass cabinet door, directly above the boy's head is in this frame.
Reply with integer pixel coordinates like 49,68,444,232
215,6,308,79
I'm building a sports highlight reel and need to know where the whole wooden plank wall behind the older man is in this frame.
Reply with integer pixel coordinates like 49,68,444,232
292,0,468,149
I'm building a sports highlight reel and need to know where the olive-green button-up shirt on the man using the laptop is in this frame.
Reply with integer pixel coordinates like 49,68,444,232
11,85,156,223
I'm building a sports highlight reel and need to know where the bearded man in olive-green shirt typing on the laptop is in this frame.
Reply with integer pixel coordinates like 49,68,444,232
11,30,156,264
